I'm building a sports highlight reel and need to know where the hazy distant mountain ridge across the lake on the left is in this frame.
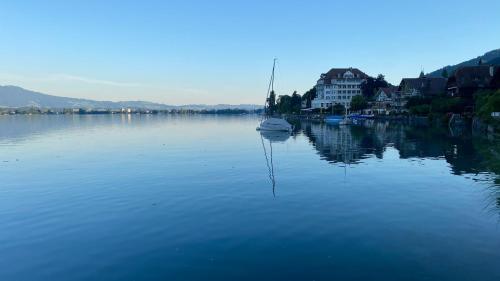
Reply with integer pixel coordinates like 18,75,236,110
0,86,262,110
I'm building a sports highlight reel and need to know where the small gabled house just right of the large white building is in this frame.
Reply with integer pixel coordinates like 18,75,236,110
372,87,406,114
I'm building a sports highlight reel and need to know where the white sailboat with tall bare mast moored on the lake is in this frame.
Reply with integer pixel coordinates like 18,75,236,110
257,59,293,132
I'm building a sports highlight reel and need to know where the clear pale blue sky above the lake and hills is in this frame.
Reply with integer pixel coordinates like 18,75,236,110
0,0,500,105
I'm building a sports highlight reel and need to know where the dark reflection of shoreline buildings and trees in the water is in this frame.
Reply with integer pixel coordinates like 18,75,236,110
298,120,500,208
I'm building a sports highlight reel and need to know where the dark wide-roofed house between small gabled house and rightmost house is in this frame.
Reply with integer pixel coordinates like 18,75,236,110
398,72,447,97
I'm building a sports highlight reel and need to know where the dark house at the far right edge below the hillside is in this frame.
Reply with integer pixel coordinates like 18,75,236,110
447,65,500,98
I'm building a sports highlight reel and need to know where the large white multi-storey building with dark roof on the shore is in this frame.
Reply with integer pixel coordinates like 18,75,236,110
311,68,368,108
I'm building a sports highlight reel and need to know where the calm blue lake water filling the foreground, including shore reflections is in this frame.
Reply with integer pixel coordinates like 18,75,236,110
0,115,500,281
